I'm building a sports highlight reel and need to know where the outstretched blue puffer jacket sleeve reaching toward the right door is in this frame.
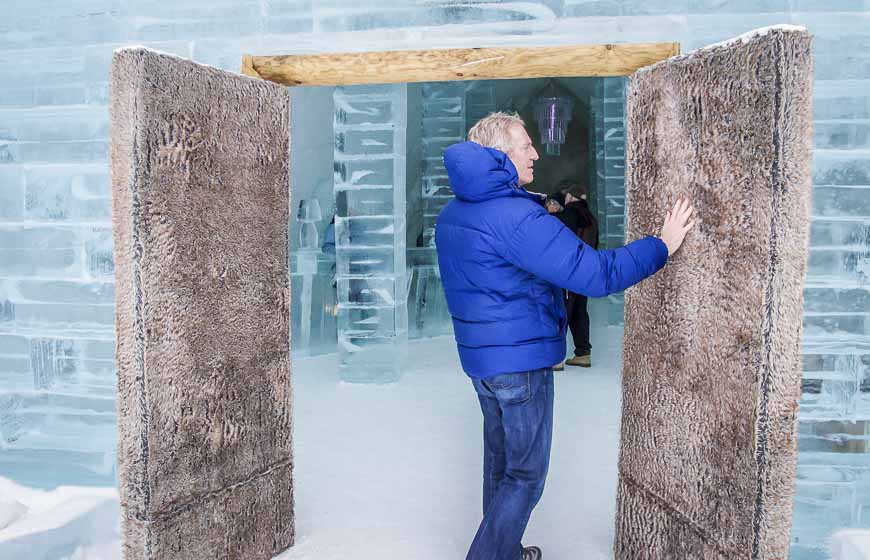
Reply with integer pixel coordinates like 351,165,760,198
503,212,668,297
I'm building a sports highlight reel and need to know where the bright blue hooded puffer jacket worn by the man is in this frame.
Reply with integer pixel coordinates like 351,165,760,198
435,142,668,378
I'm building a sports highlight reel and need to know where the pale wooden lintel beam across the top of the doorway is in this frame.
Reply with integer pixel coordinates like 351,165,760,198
243,43,680,86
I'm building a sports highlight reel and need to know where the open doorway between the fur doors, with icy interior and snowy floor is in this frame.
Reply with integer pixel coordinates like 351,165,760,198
281,77,626,560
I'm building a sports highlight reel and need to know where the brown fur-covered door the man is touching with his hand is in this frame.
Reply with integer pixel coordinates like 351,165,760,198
615,29,812,560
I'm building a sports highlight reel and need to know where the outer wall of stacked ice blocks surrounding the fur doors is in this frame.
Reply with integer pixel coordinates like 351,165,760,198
0,0,870,558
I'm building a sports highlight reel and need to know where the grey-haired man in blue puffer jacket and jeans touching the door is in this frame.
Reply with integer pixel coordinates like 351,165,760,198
435,113,694,560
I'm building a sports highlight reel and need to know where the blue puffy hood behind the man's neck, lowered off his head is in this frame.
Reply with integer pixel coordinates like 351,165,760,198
444,142,539,202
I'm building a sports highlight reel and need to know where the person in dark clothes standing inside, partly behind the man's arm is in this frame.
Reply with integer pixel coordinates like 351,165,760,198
554,181,598,367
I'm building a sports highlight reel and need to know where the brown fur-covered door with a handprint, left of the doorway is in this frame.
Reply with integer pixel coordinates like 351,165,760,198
110,48,294,560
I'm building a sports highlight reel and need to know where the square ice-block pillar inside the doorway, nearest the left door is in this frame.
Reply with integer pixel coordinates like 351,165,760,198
333,84,408,383
